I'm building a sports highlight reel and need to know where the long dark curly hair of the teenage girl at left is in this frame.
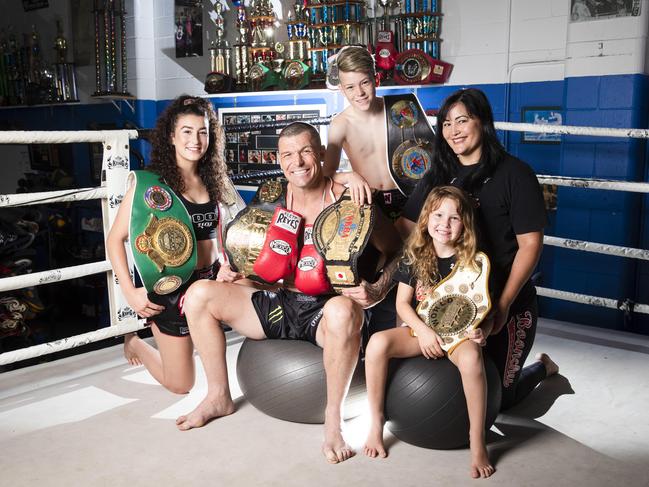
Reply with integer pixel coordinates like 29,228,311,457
147,95,227,202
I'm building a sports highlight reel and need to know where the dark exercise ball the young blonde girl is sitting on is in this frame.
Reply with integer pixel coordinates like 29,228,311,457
385,355,502,450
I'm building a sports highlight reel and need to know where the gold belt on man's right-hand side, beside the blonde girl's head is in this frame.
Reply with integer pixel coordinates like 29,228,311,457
313,190,376,292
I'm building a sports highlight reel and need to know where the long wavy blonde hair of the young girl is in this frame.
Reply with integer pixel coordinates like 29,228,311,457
403,186,477,286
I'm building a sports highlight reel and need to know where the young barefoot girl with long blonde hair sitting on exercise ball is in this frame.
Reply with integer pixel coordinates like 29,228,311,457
364,186,494,478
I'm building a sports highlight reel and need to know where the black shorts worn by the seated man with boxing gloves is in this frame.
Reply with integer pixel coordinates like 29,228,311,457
250,289,332,345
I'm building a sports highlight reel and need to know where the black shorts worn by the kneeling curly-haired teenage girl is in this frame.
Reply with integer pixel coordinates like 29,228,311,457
147,262,220,337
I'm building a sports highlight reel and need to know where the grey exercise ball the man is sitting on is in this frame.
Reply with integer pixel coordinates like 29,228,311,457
237,339,366,424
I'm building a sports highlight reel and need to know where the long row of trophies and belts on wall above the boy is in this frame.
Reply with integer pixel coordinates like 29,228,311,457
205,0,451,94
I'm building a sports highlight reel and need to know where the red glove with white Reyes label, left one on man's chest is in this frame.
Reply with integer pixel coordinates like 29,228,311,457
252,206,302,283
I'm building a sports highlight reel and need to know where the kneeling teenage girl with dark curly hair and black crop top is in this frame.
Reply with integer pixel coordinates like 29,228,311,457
106,95,243,394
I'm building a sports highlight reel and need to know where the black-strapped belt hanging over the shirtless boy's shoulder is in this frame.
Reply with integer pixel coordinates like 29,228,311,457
383,93,435,196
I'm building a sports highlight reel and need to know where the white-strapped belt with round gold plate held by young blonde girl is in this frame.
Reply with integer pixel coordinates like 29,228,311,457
410,252,491,354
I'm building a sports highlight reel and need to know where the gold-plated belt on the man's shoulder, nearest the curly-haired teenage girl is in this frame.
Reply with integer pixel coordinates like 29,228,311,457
224,180,286,279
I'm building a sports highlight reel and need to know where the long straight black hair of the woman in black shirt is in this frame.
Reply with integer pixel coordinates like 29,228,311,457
431,88,506,193
